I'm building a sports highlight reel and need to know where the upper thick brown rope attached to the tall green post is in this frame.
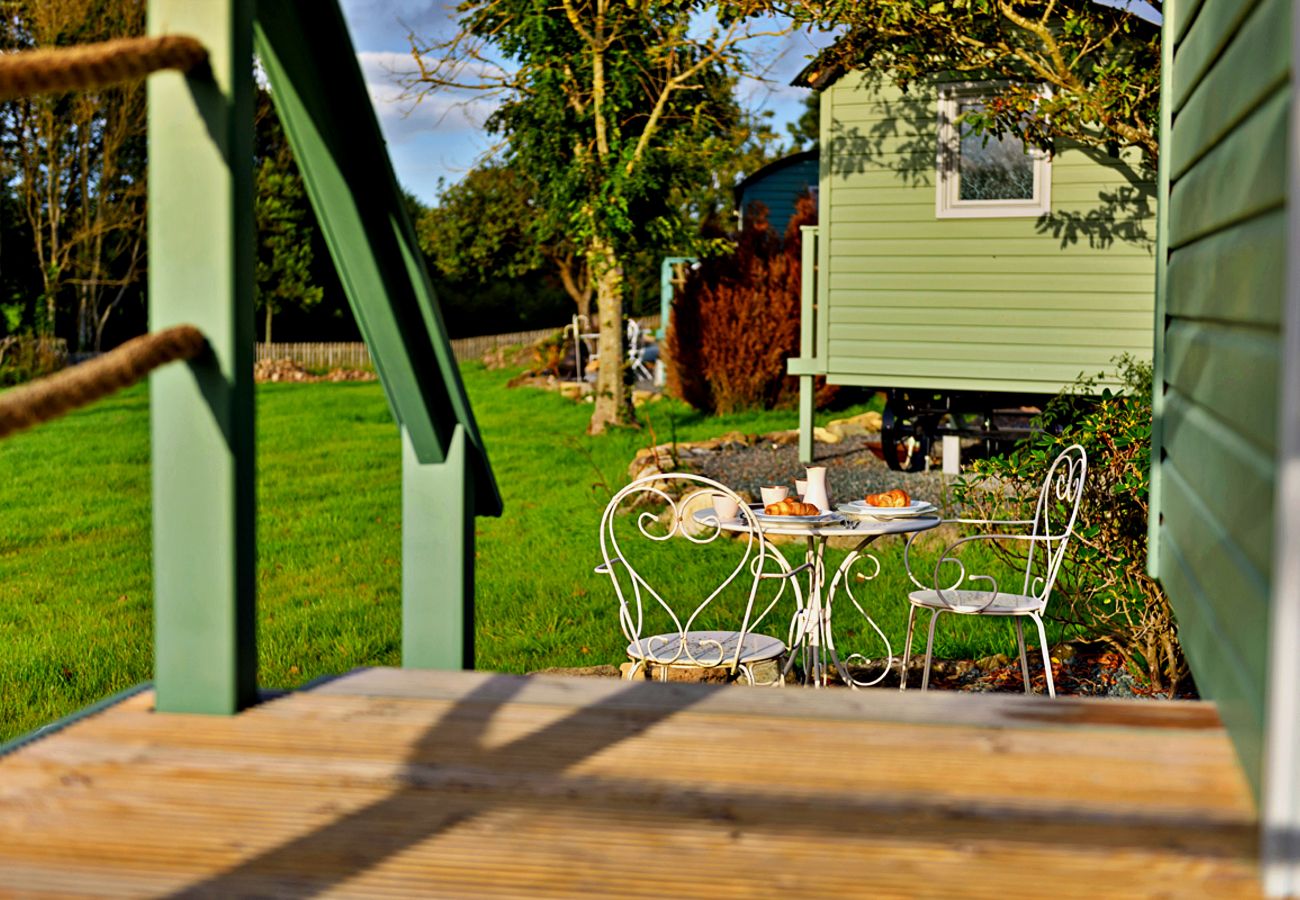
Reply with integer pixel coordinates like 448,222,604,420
0,34,208,100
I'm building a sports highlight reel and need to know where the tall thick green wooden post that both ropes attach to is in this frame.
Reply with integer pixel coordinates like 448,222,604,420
148,0,257,714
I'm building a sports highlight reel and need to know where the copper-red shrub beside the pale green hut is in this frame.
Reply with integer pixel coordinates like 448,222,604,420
667,195,824,412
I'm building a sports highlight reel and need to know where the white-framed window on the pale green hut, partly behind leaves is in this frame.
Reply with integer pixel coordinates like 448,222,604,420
935,83,1052,218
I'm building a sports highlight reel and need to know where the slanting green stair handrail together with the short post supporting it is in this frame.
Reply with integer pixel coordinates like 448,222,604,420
254,0,501,668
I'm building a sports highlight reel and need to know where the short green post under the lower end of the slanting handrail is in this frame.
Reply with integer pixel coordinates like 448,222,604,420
402,425,475,668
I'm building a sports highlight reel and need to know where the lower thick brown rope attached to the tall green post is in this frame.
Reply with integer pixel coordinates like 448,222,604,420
0,325,208,438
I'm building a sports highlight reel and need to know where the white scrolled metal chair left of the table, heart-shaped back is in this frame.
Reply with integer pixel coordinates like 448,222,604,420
595,473,806,684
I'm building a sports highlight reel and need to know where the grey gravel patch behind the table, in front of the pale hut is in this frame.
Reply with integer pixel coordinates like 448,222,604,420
690,436,945,509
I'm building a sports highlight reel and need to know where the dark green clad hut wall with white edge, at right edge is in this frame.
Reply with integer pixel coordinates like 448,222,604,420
1151,0,1300,896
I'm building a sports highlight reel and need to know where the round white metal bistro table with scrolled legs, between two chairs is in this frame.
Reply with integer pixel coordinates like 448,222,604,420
709,510,940,688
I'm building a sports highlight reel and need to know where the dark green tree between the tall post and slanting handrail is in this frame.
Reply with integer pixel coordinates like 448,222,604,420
254,91,325,343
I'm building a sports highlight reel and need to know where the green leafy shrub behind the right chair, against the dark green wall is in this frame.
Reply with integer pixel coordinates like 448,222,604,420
954,355,1187,696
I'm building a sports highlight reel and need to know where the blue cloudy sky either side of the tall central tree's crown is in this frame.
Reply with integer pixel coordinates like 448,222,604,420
330,0,829,203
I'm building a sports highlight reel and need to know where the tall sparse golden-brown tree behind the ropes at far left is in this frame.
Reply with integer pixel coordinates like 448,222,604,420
0,0,146,350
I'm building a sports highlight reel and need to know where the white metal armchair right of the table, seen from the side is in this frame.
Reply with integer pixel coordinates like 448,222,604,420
900,443,1088,697
